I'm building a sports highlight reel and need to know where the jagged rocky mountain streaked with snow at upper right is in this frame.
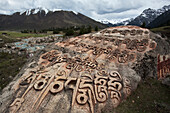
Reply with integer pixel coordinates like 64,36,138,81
128,5,170,26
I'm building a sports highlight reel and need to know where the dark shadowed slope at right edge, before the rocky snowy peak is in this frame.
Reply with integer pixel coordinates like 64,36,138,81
147,10,170,28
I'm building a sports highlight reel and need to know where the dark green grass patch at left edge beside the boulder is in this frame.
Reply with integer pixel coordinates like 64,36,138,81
0,53,26,91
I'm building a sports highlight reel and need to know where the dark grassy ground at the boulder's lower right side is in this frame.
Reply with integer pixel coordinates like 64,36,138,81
114,78,170,113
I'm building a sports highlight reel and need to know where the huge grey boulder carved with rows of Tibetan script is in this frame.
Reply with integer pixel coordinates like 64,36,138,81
0,26,170,113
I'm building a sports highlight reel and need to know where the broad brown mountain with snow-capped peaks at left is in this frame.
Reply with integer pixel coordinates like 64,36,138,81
0,8,106,30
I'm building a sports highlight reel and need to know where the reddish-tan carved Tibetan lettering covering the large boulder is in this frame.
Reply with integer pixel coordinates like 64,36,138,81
10,26,156,113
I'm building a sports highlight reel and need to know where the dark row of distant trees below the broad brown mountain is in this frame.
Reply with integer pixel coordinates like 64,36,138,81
21,25,99,36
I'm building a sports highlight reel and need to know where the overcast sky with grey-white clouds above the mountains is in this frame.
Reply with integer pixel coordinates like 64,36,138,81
0,0,170,22
